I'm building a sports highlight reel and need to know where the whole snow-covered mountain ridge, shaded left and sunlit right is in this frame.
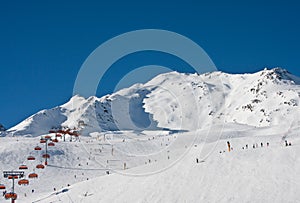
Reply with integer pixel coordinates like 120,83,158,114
8,68,300,136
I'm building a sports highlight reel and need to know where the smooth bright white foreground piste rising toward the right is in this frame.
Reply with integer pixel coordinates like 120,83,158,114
31,133,300,203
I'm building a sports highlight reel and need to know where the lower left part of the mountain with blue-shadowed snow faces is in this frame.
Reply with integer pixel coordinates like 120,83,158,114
8,88,162,137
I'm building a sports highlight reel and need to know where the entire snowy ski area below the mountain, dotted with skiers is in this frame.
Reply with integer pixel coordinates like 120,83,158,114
0,124,300,203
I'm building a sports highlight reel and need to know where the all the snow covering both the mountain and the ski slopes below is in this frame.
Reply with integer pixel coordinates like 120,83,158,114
0,68,300,202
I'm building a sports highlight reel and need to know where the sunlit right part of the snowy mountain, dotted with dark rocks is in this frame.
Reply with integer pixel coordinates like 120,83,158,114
145,68,300,130
